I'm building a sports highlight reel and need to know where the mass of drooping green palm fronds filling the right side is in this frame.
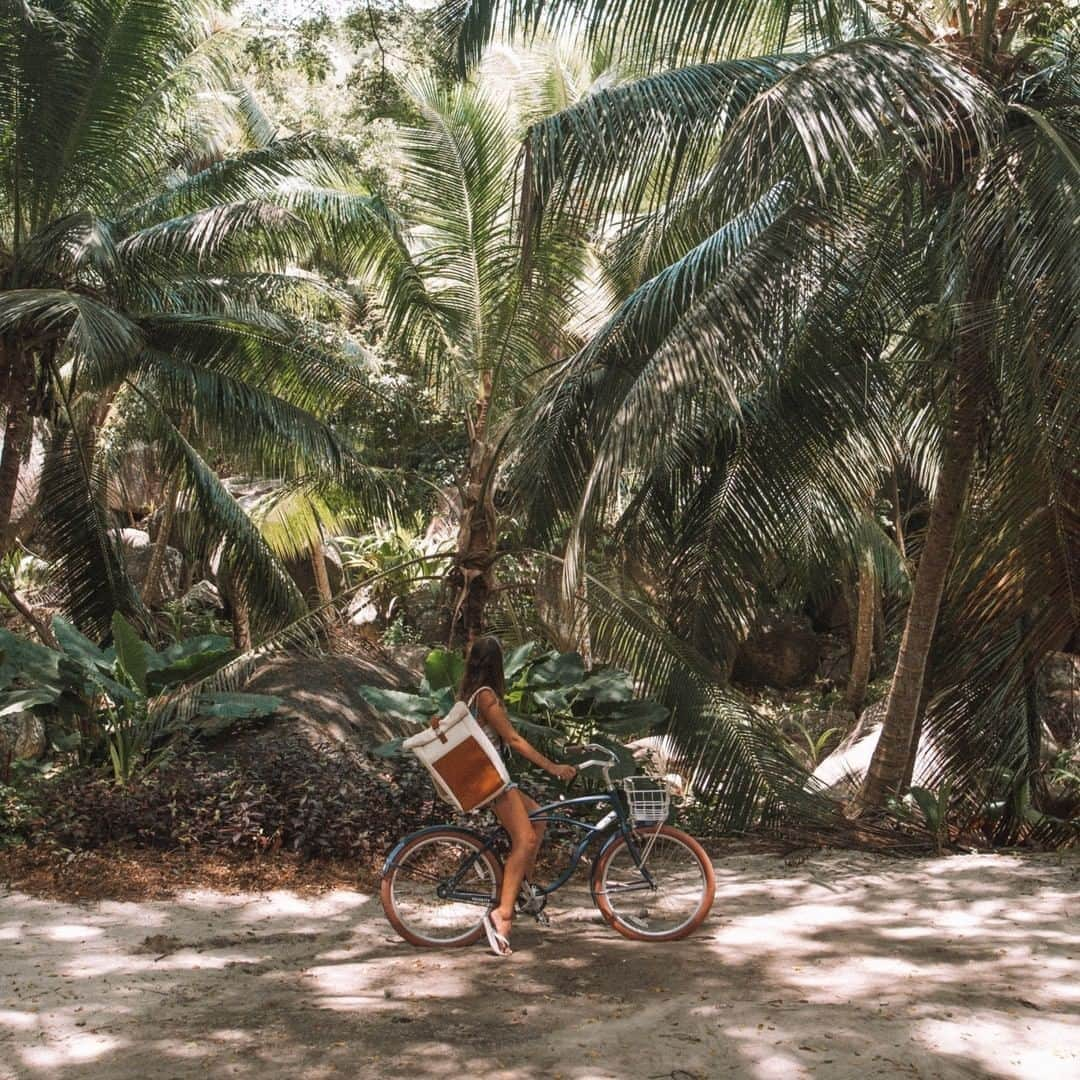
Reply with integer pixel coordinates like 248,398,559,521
446,0,1080,835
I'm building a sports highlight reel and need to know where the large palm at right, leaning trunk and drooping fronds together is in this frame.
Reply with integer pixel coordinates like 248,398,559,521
440,0,1080,807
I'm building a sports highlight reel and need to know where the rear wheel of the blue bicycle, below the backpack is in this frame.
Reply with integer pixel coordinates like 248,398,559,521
379,828,502,948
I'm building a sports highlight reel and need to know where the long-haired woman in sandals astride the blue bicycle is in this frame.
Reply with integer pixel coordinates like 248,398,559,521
432,637,578,956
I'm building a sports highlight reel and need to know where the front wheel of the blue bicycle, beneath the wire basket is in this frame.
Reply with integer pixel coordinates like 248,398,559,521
593,825,716,942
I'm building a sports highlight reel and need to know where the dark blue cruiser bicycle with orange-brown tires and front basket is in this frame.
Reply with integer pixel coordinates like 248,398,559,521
380,743,716,948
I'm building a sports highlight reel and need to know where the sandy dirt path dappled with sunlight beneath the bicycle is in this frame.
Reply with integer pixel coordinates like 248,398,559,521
0,852,1080,1080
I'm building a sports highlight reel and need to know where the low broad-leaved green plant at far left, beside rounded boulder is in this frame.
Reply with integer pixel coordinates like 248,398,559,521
0,611,281,784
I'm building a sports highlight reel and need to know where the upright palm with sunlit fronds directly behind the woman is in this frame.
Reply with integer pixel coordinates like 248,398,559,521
349,56,600,639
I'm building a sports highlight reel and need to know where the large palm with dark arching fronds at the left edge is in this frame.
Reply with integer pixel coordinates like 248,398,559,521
0,0,393,633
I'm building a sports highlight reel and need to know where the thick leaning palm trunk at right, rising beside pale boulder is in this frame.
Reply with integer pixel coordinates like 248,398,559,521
860,352,984,810
